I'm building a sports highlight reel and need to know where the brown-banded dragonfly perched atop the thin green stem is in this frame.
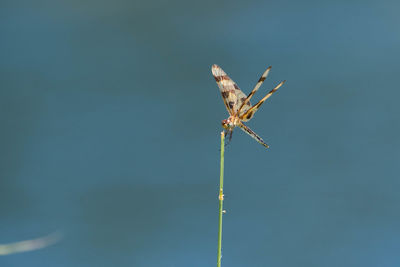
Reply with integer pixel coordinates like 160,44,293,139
211,64,286,148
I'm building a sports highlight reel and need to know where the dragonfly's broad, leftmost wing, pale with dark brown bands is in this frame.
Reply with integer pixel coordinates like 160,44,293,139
211,65,251,115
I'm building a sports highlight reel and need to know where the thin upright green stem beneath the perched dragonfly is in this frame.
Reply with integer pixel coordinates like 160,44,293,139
217,131,225,267
